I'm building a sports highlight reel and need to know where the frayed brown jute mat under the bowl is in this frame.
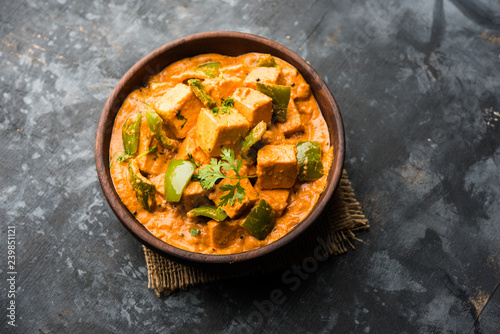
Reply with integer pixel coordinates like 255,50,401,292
143,170,370,296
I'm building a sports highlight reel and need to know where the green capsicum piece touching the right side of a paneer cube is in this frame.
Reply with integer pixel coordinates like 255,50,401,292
295,141,323,181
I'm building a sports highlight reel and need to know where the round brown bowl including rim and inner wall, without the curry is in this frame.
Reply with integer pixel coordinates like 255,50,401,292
95,31,345,266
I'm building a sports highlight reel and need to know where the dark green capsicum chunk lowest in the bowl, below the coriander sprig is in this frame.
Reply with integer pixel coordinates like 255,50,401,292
241,199,276,240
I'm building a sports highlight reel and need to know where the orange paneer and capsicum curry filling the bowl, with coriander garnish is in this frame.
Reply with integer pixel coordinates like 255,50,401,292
110,53,333,254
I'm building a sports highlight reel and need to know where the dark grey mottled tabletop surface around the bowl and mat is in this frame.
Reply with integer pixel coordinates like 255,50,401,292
0,0,500,333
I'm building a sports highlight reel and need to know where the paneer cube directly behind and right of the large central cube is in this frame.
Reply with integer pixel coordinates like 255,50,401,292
233,88,273,128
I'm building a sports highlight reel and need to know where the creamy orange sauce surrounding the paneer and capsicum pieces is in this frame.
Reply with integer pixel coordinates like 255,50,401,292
110,53,333,254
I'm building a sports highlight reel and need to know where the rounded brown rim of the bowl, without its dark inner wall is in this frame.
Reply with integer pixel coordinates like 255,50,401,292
95,31,345,265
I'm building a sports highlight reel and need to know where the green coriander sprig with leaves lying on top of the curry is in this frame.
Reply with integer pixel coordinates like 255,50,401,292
198,147,257,206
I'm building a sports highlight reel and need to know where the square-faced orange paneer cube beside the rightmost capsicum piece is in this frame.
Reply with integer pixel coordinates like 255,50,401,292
257,145,299,189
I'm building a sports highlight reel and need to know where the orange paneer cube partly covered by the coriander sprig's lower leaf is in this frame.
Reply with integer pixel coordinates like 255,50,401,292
210,179,259,218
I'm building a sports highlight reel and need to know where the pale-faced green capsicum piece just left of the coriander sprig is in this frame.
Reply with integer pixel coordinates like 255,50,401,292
165,159,196,202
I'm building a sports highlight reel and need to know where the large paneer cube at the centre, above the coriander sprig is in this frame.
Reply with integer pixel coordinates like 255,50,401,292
196,108,250,157
